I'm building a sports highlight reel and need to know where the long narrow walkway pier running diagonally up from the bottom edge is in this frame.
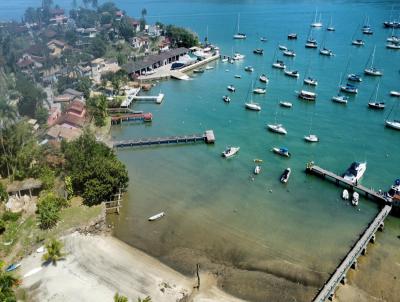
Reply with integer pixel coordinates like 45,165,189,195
313,205,392,302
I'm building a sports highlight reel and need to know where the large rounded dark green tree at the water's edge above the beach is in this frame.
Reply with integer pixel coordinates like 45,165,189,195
61,132,129,205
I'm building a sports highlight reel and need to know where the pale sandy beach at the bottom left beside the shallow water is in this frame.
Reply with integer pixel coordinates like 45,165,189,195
19,232,242,302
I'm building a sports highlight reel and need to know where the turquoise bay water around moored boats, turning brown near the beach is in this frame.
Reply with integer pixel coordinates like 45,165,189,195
0,0,400,301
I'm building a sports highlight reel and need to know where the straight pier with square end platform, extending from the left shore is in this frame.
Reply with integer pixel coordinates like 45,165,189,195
113,130,215,148
